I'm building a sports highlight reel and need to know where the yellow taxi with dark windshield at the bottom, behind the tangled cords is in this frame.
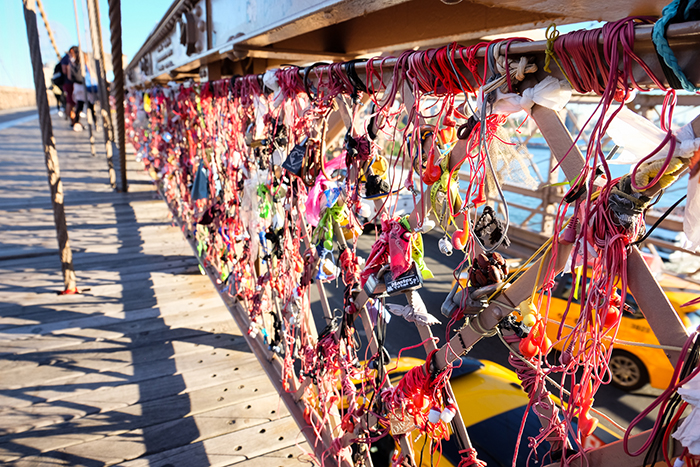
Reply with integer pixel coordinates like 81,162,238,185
370,357,619,467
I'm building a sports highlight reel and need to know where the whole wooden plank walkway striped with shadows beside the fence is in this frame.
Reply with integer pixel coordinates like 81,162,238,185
0,112,308,467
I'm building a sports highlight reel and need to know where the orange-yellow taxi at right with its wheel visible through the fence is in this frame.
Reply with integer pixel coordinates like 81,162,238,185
547,274,700,391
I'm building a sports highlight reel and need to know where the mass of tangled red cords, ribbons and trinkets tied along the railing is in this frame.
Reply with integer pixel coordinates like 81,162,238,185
127,18,697,466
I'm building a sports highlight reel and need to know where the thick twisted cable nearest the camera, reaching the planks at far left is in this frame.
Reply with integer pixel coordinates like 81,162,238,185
23,0,77,294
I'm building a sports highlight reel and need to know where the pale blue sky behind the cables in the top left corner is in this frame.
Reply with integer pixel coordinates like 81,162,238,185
0,0,174,88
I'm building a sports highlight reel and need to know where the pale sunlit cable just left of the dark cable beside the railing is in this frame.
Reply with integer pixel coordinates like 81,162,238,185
87,0,117,187
